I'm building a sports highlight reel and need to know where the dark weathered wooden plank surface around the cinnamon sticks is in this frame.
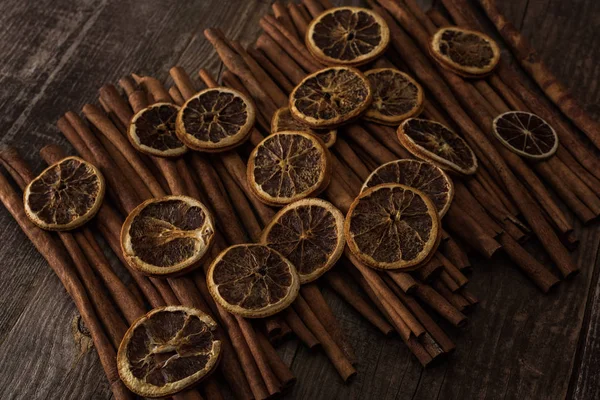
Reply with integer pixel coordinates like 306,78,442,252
0,0,600,400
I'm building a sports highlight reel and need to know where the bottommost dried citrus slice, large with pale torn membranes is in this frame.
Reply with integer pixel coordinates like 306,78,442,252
117,306,221,398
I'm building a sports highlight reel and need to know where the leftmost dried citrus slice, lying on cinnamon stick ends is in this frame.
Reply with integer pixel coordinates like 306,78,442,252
23,157,105,231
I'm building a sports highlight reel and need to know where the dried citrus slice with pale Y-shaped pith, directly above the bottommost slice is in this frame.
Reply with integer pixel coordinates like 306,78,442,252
121,196,215,276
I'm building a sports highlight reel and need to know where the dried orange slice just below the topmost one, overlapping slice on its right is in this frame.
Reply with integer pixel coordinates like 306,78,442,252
290,67,373,129
